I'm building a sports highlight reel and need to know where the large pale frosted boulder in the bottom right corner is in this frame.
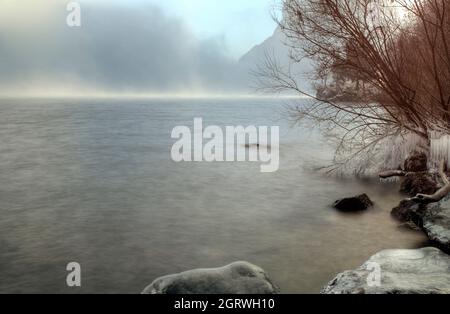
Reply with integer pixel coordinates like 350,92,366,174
322,248,450,294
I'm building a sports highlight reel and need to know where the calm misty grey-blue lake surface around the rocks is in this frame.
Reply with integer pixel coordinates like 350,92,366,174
0,99,427,293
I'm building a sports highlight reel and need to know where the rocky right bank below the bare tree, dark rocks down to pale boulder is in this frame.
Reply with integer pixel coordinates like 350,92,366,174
321,154,450,294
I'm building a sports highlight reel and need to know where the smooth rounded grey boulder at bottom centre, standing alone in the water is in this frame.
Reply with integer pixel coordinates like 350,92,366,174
142,262,279,294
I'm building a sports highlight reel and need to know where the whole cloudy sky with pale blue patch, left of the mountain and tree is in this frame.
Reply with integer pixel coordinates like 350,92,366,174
0,0,276,94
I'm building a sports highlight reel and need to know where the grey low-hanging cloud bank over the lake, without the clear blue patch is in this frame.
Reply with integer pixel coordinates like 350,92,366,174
0,0,250,93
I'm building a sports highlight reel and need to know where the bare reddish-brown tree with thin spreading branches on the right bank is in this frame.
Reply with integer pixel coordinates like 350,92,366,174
258,0,450,175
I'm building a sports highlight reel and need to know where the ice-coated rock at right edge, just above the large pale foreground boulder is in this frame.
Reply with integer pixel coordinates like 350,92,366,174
421,200,450,253
